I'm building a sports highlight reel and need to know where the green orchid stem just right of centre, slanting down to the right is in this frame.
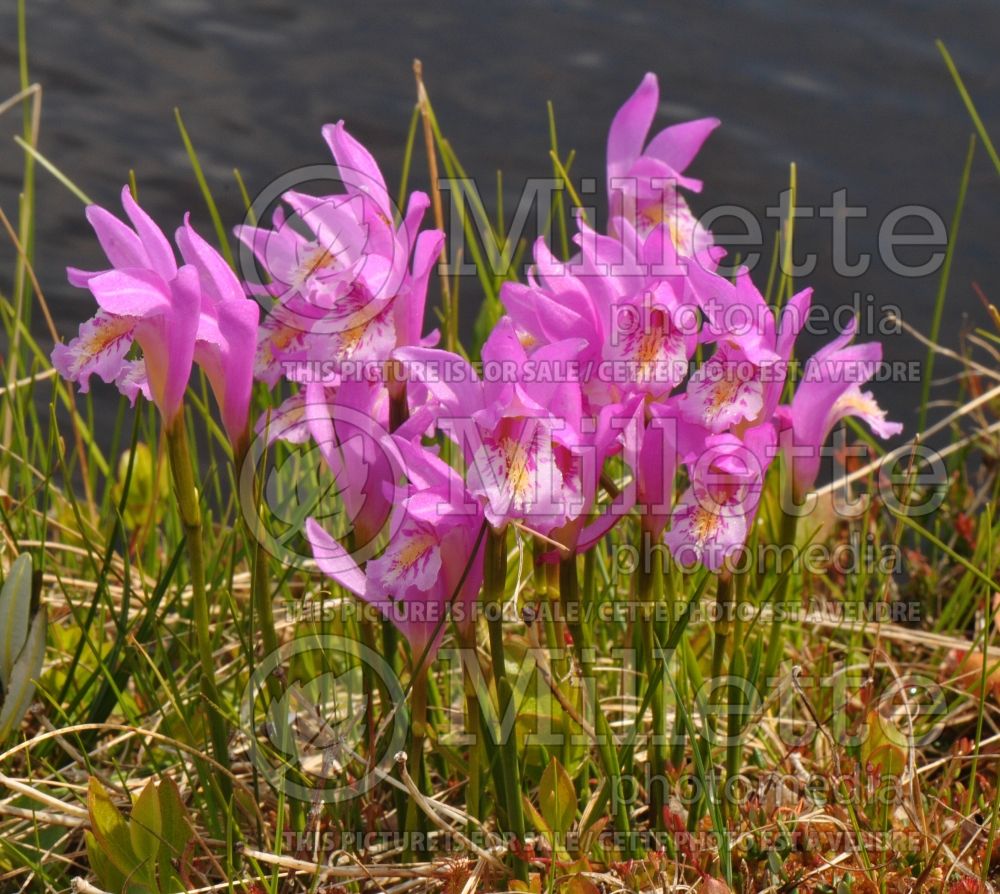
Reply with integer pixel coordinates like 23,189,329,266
559,556,636,859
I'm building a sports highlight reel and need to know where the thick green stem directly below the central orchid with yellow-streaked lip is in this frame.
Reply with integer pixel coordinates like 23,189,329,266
483,528,528,882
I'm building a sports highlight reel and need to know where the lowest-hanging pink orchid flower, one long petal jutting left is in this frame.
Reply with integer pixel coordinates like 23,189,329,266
306,437,483,662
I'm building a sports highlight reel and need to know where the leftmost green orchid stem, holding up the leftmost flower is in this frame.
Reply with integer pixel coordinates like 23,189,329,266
167,411,232,801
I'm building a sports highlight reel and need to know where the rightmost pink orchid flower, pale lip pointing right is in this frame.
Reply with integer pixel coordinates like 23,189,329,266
779,320,903,499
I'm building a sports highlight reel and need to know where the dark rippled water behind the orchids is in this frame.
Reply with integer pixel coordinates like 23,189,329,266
0,0,1000,438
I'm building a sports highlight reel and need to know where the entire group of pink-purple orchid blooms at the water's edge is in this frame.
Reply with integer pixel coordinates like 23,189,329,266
53,74,901,648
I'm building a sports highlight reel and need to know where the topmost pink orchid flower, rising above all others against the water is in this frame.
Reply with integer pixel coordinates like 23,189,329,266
607,73,719,257
